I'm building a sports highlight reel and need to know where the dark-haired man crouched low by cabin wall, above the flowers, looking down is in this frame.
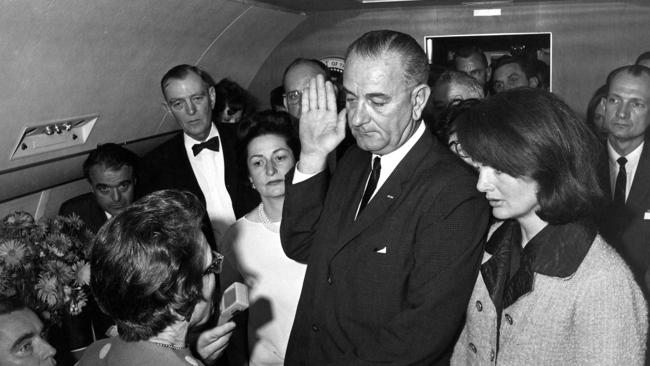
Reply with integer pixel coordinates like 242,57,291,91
59,143,138,233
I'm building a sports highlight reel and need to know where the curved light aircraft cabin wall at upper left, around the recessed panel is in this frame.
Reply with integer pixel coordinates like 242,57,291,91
0,0,305,219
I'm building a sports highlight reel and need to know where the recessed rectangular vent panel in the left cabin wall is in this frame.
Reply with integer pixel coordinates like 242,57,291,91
11,114,99,160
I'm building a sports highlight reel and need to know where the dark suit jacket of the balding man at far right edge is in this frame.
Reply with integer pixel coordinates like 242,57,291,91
599,138,650,299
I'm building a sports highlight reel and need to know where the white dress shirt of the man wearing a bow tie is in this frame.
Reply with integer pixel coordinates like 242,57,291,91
183,124,236,245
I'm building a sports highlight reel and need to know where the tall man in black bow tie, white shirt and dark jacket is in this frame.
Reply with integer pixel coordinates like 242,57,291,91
140,65,259,249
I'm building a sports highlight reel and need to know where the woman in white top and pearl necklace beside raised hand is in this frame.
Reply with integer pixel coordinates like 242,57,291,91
221,111,306,365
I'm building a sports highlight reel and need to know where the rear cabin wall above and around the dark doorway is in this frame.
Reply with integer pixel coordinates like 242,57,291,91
250,0,650,113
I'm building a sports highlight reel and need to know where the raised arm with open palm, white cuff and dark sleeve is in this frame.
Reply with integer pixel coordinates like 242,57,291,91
280,75,346,263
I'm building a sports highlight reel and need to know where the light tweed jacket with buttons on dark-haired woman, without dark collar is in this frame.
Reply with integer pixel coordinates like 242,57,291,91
451,220,648,366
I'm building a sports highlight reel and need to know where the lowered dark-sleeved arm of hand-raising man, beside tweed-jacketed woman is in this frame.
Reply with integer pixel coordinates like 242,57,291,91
331,176,489,365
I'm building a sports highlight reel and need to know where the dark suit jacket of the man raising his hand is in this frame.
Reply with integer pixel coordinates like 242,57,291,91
281,132,489,365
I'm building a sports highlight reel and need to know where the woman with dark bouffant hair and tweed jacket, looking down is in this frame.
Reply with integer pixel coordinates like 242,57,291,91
452,88,648,365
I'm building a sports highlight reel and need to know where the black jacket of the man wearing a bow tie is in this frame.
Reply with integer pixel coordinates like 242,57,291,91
137,124,259,248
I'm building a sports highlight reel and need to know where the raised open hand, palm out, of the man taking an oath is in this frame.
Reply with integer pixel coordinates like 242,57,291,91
298,75,346,174
